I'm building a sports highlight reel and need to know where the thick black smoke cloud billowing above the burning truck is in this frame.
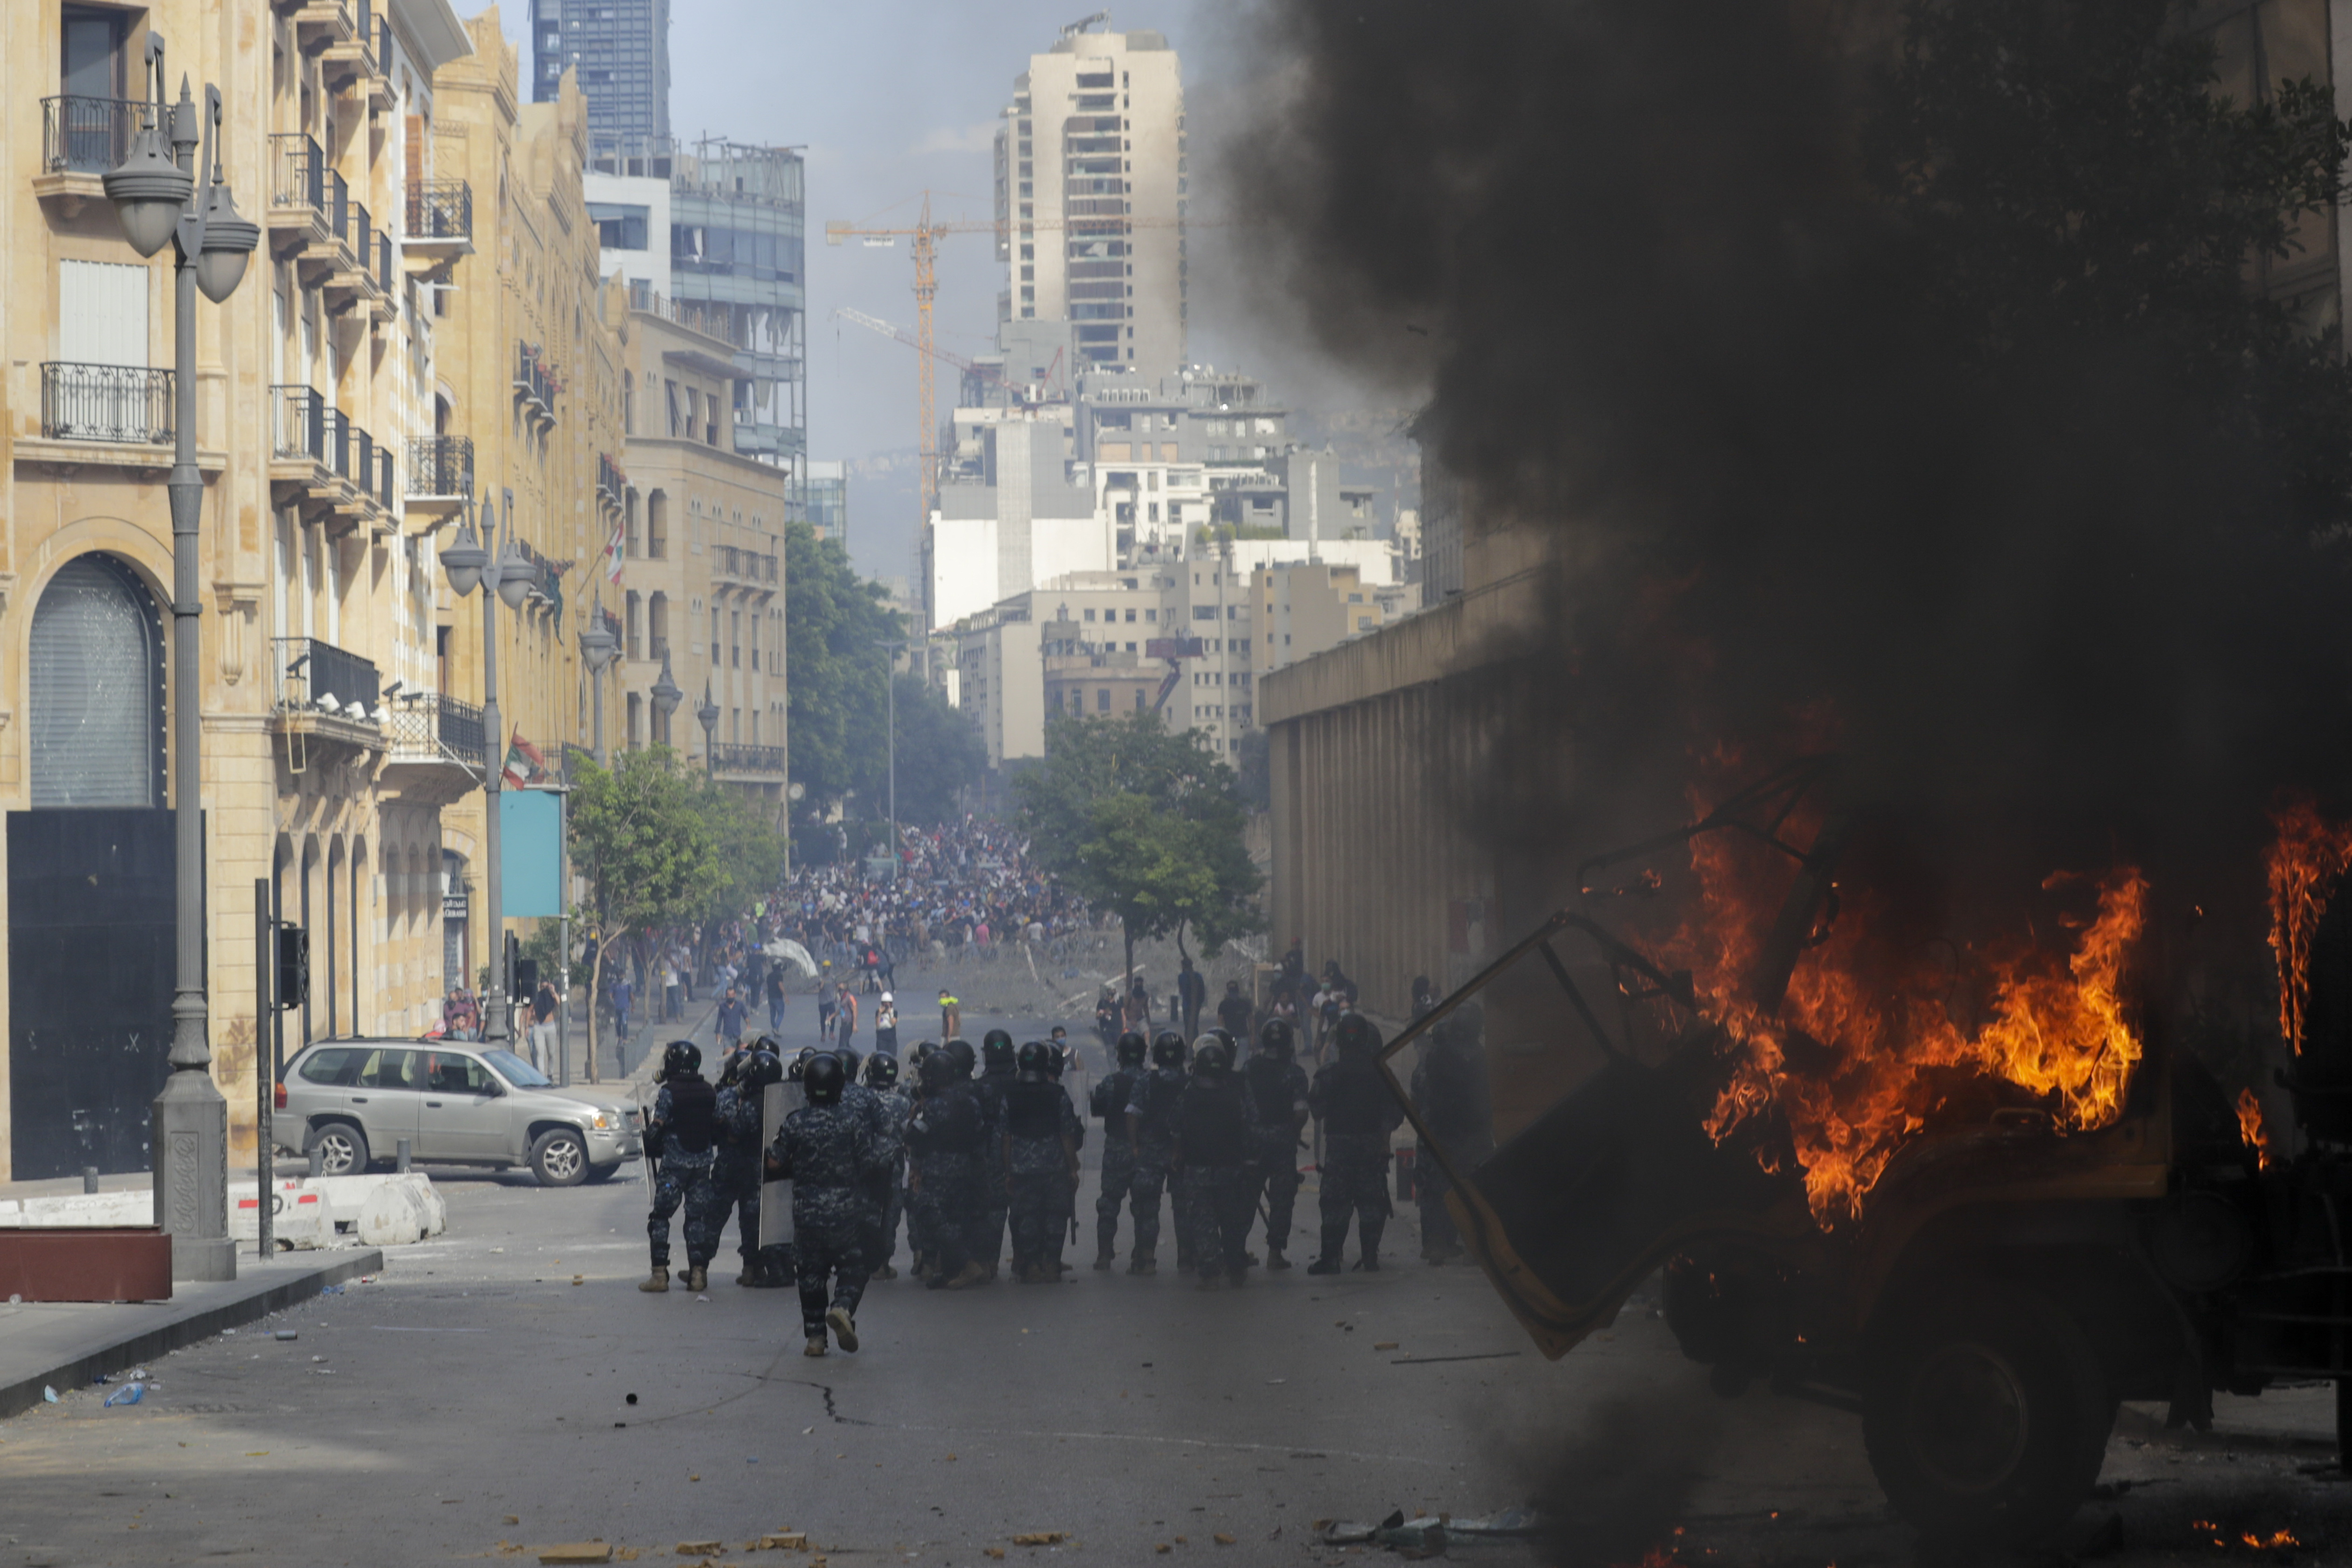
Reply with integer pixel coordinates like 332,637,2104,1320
1225,0,2352,945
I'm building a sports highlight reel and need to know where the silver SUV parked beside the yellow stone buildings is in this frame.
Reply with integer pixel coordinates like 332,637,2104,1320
273,1039,642,1187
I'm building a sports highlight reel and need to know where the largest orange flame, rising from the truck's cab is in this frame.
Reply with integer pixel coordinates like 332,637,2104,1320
1667,771,2147,1227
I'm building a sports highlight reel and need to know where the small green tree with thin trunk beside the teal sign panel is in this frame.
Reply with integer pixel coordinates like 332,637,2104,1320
569,745,727,1084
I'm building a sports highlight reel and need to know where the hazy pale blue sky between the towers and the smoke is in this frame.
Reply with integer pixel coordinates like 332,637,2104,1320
480,0,1355,576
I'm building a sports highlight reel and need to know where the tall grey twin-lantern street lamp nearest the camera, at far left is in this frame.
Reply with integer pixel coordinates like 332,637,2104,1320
103,33,268,1279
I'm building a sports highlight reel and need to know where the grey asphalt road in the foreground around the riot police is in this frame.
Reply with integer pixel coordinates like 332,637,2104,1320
0,1006,2352,1568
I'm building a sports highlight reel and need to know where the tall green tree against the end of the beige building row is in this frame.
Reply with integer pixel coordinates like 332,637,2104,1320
783,522,903,814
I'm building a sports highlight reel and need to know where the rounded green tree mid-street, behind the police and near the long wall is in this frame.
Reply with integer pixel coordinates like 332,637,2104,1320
1014,712,1263,973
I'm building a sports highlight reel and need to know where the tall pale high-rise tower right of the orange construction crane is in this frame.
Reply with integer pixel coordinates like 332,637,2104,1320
992,20,1186,381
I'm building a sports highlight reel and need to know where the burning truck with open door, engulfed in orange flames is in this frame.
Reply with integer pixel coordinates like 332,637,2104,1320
1383,760,2352,1545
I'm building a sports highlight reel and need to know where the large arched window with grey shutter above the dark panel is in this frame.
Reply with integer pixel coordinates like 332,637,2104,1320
28,555,165,806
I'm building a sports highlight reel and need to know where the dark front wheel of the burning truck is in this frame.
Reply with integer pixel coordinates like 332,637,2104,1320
1863,1286,2114,1545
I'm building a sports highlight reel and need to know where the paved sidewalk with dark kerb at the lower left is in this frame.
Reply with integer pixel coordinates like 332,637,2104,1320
0,1248,384,1420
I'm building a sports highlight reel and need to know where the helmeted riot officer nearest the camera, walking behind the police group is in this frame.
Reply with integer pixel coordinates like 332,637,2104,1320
767,1053,875,1356
